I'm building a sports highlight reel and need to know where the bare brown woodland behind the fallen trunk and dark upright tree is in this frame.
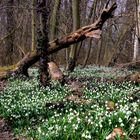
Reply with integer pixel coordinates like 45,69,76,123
0,0,140,66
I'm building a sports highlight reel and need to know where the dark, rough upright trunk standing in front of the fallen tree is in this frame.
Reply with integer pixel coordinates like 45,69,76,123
37,0,49,86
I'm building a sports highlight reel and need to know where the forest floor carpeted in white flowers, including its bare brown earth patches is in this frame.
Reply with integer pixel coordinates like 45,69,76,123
0,66,140,140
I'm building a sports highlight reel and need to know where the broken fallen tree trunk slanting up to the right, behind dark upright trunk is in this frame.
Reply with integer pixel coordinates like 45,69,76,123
0,0,117,77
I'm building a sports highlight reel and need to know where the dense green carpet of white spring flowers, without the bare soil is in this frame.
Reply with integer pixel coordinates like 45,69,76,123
0,66,140,140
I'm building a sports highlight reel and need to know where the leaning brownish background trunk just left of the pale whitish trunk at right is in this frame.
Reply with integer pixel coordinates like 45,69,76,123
106,0,134,66
